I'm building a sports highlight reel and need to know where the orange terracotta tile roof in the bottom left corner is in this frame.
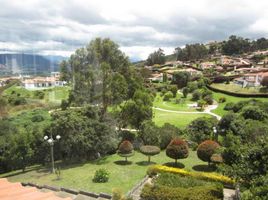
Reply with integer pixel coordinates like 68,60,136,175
0,178,71,200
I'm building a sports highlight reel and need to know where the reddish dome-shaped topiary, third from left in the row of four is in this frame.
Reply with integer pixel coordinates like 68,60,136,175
166,138,189,164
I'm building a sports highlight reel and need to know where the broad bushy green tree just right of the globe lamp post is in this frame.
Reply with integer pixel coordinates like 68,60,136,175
49,107,118,160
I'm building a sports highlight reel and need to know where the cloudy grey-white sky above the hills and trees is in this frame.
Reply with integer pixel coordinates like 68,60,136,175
0,0,268,60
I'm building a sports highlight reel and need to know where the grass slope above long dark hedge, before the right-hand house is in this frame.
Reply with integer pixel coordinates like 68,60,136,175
211,82,268,94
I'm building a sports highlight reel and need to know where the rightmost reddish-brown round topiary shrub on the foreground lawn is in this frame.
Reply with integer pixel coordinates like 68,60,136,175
197,140,220,164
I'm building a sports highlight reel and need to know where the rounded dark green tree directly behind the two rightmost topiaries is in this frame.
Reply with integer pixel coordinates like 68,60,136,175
186,117,217,144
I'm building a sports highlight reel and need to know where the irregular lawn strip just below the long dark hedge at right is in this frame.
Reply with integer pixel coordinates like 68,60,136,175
212,92,268,116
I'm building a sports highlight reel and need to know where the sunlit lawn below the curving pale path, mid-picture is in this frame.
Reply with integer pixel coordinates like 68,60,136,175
153,109,210,128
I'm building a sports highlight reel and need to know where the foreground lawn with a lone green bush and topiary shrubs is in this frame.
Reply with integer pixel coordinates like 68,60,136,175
0,151,207,194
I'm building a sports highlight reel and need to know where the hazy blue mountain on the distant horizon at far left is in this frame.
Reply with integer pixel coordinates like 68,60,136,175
0,54,68,75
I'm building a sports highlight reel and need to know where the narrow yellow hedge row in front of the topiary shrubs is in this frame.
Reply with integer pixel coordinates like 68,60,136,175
147,165,235,185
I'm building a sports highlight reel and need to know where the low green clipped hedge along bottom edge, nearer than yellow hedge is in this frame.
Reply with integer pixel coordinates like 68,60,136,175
141,184,223,200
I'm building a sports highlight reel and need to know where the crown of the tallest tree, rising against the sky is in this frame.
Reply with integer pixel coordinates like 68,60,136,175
68,38,130,111
